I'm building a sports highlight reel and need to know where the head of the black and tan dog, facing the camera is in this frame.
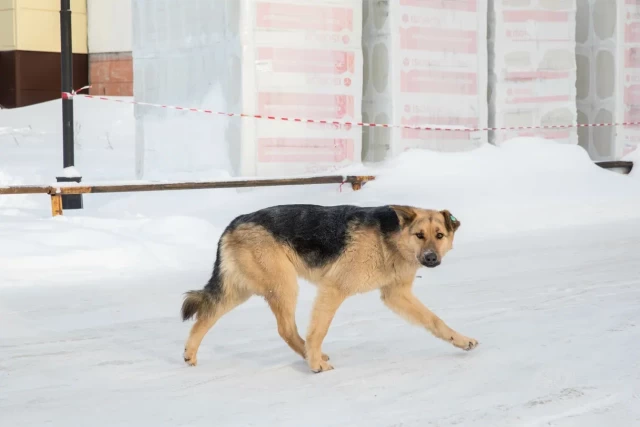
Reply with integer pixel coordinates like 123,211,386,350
390,205,460,268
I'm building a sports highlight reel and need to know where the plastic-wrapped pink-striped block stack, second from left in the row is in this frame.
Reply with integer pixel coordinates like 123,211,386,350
363,0,487,161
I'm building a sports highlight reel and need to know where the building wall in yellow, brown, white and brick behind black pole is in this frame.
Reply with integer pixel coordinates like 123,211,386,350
0,0,133,108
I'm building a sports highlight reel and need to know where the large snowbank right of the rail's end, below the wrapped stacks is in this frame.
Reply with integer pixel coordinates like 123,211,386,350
344,138,640,238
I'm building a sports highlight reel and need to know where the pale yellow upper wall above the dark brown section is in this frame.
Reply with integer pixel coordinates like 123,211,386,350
0,0,87,53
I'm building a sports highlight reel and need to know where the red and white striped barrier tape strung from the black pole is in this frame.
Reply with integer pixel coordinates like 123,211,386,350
62,86,640,132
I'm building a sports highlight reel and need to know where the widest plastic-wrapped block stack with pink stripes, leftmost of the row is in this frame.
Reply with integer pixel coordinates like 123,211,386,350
133,0,362,180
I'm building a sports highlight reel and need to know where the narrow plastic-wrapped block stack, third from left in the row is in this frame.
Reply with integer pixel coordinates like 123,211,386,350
489,0,578,144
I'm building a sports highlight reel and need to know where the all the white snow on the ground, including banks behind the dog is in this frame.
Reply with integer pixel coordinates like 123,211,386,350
0,98,640,427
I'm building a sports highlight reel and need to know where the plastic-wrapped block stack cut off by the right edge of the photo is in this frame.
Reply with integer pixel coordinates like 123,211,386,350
576,0,640,160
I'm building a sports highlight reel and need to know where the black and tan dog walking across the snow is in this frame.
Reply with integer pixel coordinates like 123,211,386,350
181,204,478,373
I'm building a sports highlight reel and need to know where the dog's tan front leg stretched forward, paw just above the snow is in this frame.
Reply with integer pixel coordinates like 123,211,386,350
380,285,478,350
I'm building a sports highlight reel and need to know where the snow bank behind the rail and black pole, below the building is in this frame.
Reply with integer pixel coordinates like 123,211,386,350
0,97,135,186
